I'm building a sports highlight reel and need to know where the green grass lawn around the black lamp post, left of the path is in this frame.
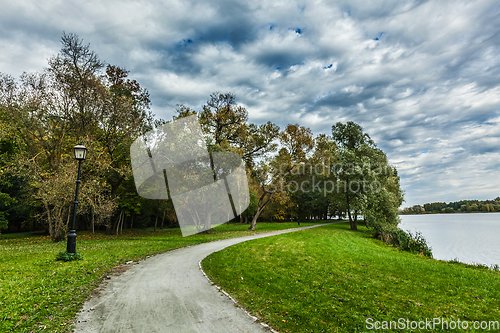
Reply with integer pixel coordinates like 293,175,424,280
0,223,318,332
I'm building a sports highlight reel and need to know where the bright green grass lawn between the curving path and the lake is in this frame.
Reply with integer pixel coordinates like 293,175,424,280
202,224,500,333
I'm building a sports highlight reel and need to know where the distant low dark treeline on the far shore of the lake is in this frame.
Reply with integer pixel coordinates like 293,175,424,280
399,197,500,214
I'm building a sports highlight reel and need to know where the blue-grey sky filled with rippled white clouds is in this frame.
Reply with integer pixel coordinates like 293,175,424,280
0,0,500,206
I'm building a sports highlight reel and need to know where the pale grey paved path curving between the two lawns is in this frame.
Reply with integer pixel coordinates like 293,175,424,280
75,223,336,333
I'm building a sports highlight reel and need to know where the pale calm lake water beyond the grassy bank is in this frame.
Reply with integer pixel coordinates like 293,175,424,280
399,213,500,266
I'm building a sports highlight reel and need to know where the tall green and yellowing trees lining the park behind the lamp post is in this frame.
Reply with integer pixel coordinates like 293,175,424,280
0,34,403,241
